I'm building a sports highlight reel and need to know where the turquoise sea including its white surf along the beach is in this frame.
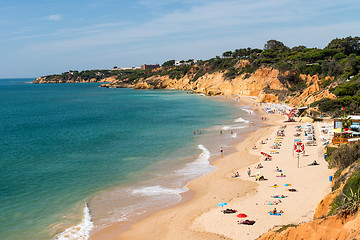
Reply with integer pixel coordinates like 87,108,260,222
0,79,254,240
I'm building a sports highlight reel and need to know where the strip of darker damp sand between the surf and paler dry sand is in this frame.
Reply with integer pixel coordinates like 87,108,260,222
90,96,283,240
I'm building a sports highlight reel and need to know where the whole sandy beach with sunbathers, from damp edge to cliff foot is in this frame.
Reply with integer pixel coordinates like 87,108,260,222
90,97,332,240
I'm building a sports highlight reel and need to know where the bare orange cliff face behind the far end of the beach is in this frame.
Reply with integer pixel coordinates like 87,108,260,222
117,65,335,107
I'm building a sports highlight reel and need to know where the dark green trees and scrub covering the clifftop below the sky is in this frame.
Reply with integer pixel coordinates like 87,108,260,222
37,37,360,115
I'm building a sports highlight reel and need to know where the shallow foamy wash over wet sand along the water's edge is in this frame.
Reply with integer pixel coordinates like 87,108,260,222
54,89,255,239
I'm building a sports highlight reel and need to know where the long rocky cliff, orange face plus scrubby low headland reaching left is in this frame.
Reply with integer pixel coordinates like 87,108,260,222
34,60,335,107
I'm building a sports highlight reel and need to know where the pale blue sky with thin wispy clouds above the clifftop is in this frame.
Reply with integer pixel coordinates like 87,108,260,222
0,0,360,78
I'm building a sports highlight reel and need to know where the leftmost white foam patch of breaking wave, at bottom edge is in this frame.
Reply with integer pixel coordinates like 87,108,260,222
53,204,94,240
